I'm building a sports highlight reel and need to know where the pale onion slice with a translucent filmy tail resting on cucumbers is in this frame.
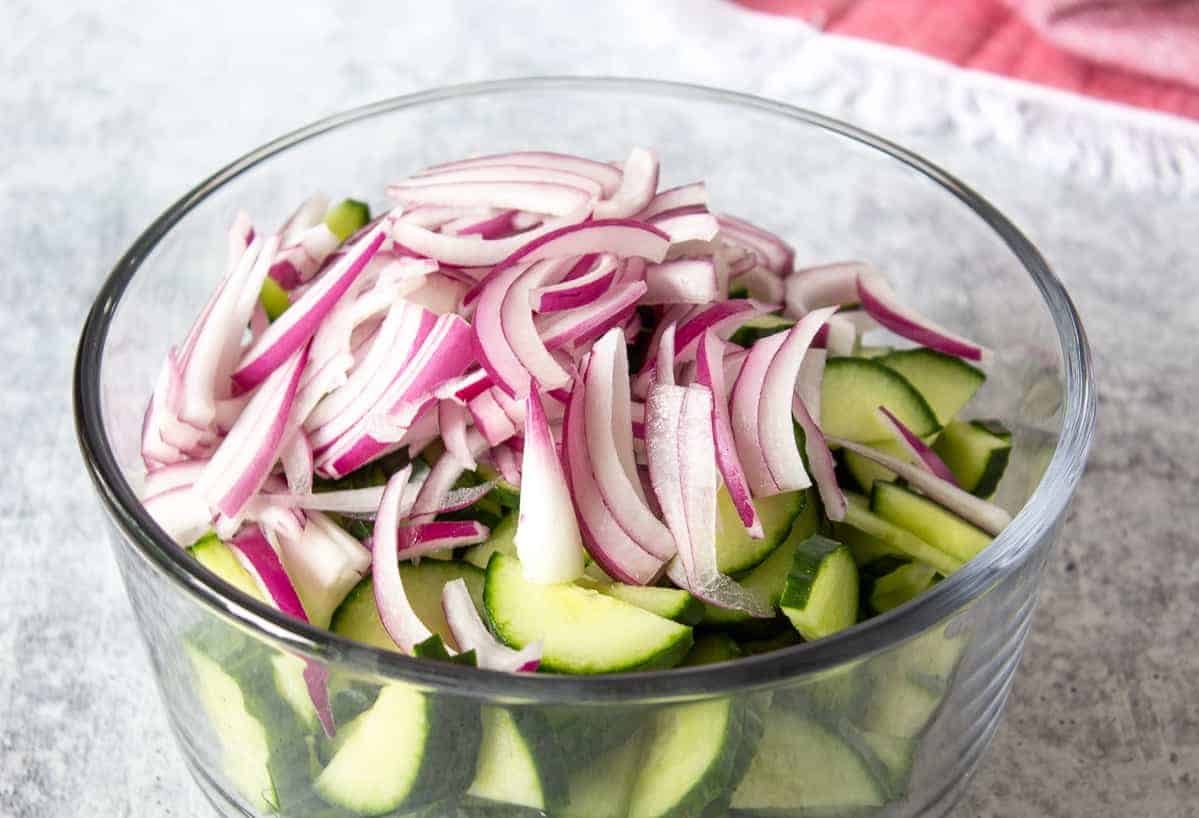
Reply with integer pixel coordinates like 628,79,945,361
645,384,775,618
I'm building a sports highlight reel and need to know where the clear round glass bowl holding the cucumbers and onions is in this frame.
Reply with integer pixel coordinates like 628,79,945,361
74,78,1095,818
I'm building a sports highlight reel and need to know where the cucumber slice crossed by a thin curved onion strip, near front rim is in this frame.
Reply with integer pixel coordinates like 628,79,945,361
329,560,483,650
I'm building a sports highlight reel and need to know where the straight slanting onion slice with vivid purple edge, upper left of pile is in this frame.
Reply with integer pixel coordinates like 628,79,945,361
233,227,385,390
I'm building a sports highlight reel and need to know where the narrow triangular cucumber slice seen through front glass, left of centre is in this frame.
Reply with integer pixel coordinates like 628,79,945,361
466,706,566,814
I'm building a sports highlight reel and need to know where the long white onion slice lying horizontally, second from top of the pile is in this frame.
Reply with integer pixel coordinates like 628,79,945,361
387,176,595,216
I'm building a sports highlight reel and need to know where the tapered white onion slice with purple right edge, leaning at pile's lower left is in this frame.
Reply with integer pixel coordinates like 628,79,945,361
195,345,308,518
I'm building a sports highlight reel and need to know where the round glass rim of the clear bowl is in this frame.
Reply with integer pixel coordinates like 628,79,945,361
73,77,1095,704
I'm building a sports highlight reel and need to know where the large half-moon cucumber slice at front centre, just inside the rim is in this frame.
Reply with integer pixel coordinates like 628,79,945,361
483,553,692,673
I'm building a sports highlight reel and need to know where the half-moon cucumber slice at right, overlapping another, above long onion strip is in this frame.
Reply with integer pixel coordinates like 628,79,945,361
820,357,940,444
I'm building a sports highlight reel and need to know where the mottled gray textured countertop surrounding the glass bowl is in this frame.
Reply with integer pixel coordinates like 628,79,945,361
0,0,1199,818
